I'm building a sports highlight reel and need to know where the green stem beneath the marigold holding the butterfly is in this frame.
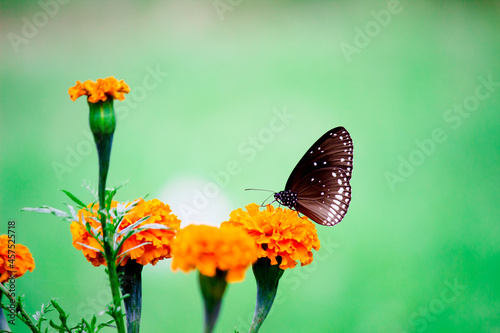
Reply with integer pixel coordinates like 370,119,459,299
248,257,285,333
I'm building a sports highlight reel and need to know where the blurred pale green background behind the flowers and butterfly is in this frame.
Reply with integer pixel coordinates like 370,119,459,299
0,0,500,333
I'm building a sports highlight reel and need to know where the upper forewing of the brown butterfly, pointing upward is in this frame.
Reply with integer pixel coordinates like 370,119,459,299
285,127,353,192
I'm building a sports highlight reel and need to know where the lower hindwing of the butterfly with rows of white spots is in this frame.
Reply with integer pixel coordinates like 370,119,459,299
296,168,351,226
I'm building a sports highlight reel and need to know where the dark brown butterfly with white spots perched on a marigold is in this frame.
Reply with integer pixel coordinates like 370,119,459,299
274,127,353,226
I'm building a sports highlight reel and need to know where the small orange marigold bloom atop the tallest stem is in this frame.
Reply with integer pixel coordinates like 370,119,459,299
68,76,130,103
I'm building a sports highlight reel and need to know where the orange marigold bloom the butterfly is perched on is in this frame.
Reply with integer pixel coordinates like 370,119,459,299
222,203,320,269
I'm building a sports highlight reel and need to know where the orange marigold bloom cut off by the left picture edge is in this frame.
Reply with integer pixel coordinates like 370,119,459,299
0,235,35,283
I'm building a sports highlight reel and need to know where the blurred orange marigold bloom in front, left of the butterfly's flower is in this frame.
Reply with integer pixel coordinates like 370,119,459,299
172,225,257,282
